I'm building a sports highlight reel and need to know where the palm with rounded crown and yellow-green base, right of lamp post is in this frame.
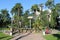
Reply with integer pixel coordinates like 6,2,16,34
31,4,40,31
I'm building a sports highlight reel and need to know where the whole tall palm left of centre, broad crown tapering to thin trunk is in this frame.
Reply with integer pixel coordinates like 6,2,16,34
11,3,23,32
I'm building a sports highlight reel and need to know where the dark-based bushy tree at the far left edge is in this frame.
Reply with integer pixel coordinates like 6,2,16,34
0,9,11,27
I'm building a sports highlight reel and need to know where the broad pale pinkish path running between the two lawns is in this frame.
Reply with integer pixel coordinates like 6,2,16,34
11,33,45,40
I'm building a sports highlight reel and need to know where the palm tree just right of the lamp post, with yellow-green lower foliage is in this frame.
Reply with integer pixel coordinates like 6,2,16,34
31,4,40,31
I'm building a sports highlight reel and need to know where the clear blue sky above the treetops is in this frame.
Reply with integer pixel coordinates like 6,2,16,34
0,0,60,16
